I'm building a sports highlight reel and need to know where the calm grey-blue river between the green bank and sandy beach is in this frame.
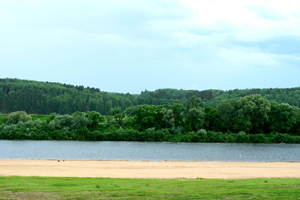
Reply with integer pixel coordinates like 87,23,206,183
0,140,300,162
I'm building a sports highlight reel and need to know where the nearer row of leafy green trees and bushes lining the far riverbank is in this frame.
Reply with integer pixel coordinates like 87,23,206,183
0,94,300,143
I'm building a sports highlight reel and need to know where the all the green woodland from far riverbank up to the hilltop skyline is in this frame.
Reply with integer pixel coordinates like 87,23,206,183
0,79,300,143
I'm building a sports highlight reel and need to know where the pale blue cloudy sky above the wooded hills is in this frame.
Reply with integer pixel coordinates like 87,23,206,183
0,0,300,94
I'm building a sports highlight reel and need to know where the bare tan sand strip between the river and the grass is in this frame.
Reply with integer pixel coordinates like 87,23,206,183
0,159,300,179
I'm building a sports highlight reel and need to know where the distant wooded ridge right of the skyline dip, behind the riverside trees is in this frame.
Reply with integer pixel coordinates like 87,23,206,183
138,87,300,107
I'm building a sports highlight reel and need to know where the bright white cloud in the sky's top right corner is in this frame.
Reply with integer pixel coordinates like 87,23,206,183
177,0,300,42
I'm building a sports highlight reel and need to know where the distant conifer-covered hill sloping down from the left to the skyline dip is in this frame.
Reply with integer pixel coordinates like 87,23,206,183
0,79,136,114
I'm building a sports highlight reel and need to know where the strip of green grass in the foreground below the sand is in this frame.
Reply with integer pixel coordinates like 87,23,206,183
0,176,300,199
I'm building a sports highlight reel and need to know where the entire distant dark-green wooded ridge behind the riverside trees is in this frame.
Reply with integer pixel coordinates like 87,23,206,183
0,78,300,115
